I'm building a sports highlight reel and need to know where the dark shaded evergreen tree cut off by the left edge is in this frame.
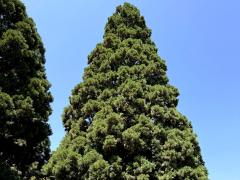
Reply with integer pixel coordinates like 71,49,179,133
0,0,52,179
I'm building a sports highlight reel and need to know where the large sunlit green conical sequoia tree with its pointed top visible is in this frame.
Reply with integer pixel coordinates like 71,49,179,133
44,3,208,180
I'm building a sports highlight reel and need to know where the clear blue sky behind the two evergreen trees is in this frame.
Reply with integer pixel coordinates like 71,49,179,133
23,0,240,180
